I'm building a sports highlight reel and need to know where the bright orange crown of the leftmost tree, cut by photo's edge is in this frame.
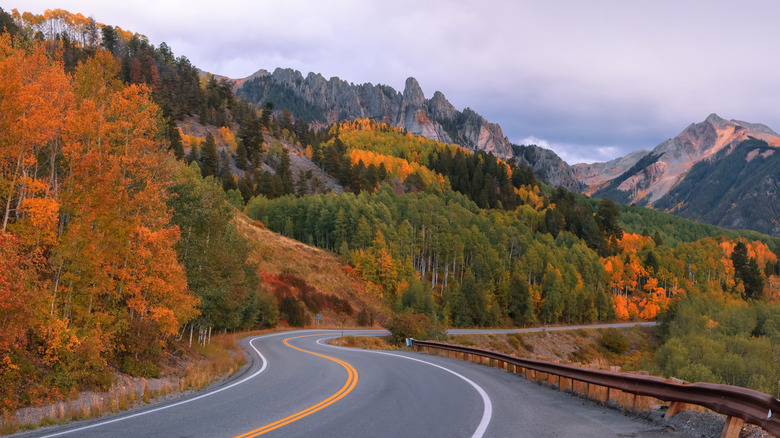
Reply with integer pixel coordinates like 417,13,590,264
0,34,73,241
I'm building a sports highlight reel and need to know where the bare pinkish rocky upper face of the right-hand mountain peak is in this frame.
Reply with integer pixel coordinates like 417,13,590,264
592,114,780,206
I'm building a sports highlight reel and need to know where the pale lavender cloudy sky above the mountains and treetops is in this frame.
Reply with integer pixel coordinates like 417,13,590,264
10,0,780,164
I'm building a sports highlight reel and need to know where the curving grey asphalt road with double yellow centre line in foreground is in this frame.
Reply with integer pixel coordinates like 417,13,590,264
19,322,673,438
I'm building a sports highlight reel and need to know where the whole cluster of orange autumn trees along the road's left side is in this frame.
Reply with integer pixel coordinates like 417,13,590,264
0,37,198,410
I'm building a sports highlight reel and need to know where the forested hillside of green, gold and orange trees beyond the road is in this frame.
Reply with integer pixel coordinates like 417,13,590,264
247,119,777,326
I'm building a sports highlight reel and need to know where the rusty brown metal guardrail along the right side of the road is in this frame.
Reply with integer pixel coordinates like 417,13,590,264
410,339,780,437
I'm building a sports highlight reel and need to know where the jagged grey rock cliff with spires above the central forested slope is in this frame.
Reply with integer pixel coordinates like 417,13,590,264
235,68,512,159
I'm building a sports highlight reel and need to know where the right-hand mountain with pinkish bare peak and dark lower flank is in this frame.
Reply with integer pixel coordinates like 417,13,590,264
574,114,780,236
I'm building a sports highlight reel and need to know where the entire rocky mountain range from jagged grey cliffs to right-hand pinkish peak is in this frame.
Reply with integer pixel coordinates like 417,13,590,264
234,68,780,236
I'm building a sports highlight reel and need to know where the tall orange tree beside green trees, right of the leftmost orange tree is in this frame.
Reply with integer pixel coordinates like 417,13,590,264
57,56,197,370
